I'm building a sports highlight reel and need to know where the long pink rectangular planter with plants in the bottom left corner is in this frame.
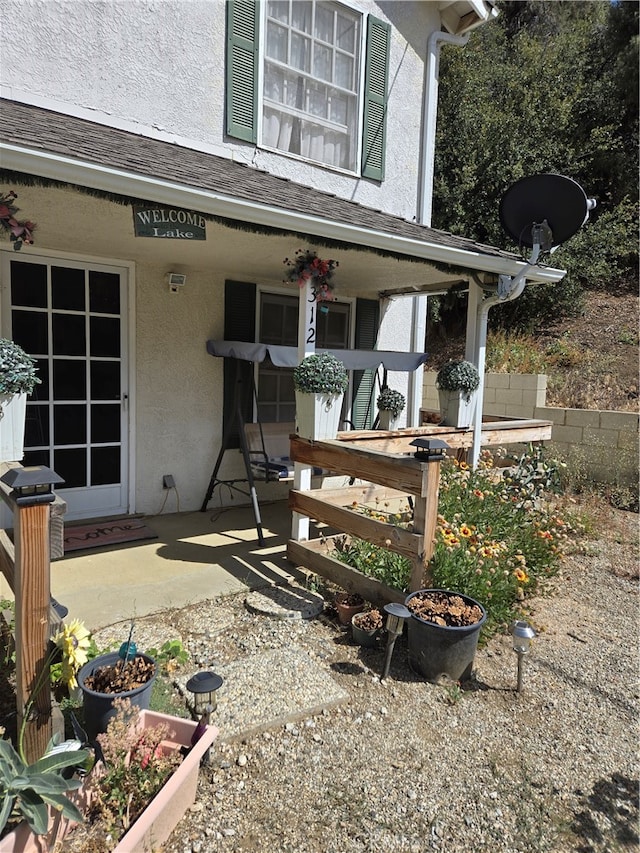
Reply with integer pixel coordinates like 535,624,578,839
0,700,218,853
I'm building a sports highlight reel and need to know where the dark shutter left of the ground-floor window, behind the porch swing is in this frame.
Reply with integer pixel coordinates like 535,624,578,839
222,281,256,447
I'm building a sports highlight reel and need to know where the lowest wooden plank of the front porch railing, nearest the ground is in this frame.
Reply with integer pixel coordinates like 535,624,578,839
287,539,407,607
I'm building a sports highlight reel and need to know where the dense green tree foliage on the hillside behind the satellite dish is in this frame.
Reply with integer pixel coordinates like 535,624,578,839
433,0,638,327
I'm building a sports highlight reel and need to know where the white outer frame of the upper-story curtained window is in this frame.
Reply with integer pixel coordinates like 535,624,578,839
257,0,367,176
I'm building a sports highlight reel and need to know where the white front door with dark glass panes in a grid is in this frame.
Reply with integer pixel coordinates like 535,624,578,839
2,252,129,520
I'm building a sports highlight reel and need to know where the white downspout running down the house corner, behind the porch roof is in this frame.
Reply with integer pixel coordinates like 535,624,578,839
407,31,469,426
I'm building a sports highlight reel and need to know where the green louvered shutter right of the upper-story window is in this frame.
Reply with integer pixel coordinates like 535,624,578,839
362,15,391,181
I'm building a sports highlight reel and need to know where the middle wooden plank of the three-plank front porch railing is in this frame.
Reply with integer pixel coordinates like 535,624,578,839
289,489,423,560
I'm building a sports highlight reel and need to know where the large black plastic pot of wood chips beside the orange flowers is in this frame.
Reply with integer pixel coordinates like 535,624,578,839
404,589,487,683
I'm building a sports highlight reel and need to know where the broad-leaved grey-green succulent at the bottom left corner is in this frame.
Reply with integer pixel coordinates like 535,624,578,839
0,739,91,835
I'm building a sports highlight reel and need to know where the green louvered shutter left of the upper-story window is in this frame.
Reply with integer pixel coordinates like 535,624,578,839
226,0,259,142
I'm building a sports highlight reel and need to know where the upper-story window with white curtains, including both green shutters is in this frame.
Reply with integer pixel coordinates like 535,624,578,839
226,0,390,180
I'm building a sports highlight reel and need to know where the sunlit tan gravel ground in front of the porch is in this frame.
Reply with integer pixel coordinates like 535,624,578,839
131,506,640,853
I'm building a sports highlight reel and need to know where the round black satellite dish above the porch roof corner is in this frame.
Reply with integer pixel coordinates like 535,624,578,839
500,174,596,251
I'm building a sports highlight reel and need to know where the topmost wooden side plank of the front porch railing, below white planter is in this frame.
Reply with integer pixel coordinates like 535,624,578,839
291,436,426,495
